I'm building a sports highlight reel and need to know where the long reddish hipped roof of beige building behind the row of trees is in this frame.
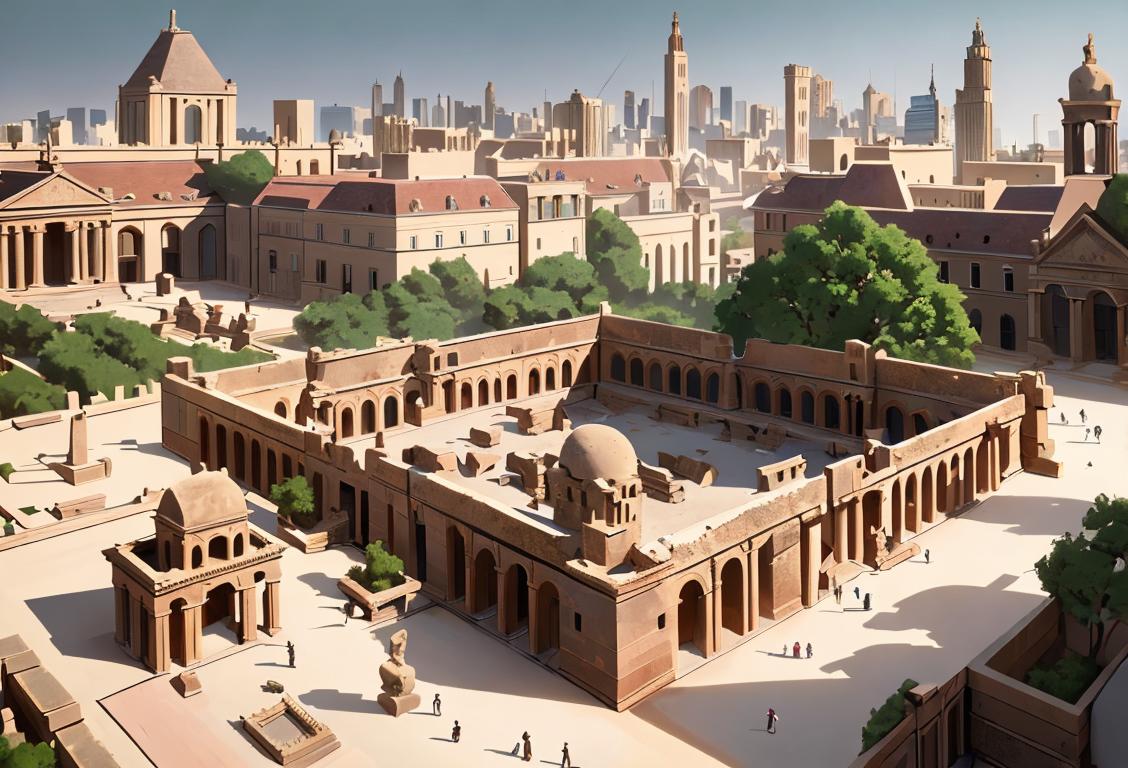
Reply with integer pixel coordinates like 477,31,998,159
254,176,517,215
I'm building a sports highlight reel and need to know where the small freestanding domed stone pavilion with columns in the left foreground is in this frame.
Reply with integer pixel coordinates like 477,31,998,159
103,471,284,672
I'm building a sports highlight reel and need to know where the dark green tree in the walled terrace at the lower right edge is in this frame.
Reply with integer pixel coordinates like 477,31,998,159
1034,494,1128,657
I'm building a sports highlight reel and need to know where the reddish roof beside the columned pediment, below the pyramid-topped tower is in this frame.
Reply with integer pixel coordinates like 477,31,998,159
63,160,219,208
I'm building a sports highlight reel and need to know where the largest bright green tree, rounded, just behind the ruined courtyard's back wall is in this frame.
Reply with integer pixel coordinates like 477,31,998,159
716,202,979,368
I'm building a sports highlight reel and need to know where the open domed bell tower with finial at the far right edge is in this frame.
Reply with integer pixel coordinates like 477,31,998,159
1058,33,1120,176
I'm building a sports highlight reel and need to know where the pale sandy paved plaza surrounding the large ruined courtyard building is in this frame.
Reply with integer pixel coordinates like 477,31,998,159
0,349,1128,768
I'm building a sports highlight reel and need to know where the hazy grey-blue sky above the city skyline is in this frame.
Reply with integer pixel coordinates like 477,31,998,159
0,0,1128,143
